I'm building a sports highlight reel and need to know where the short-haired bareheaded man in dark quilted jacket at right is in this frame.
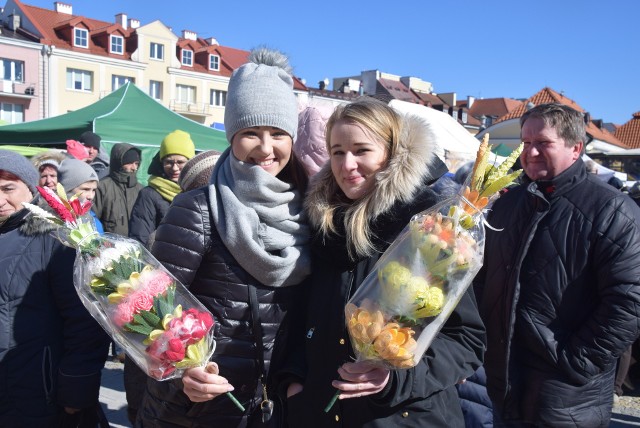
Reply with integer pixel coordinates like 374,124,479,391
476,104,640,427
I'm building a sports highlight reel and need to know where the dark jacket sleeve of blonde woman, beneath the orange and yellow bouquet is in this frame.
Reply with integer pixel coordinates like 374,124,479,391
372,287,486,407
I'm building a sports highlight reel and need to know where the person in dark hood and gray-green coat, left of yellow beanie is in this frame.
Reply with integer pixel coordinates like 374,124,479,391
93,143,142,236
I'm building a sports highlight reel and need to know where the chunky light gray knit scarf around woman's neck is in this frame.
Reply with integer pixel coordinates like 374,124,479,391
209,148,310,287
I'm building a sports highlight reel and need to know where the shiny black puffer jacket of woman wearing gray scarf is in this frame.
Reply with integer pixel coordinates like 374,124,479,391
138,187,300,428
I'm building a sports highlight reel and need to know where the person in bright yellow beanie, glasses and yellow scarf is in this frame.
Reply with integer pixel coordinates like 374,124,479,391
129,129,195,248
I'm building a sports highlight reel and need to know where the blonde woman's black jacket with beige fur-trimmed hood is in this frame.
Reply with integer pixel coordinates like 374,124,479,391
281,112,484,428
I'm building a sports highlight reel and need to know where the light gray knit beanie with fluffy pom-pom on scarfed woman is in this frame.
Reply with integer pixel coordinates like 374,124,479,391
224,48,298,142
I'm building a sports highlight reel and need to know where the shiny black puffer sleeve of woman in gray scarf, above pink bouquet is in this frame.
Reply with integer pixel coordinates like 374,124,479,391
151,188,213,288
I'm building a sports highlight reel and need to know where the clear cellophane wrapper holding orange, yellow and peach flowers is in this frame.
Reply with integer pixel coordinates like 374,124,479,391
345,195,484,369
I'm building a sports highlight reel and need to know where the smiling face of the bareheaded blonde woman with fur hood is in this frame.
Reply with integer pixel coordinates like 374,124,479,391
329,120,388,200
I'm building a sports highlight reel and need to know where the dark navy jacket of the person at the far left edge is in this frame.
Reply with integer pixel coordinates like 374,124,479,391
0,202,109,427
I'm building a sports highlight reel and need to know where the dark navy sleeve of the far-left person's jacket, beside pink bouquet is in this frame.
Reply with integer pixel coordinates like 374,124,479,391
48,238,110,409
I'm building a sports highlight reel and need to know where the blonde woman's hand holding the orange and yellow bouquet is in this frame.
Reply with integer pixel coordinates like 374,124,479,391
332,362,390,399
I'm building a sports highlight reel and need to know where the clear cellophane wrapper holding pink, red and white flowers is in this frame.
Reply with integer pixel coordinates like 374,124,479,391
70,232,215,380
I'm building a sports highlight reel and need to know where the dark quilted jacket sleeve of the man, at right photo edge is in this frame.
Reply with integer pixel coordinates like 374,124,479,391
557,195,640,383
